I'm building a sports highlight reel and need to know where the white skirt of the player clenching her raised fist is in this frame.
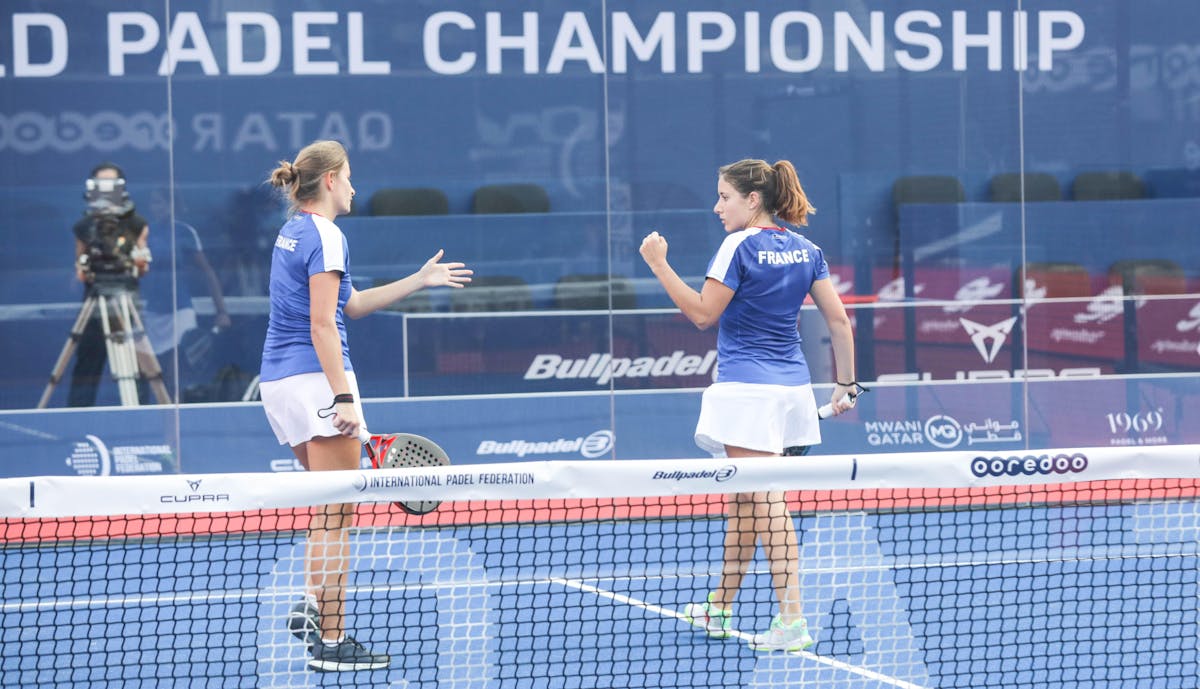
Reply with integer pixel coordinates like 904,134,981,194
696,383,821,457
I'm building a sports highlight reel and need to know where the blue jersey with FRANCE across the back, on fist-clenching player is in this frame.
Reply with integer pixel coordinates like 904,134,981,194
707,227,829,385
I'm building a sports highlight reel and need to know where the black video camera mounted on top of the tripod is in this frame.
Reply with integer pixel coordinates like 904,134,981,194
79,178,150,280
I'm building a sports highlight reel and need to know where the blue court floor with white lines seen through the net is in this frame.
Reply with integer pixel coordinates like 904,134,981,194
0,501,1200,689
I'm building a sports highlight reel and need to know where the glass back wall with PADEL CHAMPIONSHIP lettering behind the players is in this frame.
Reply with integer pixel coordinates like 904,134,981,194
0,0,1200,475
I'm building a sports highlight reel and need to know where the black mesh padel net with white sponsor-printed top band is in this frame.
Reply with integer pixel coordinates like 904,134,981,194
0,445,1200,689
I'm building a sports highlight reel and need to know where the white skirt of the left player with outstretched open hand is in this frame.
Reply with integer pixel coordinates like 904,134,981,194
258,371,366,447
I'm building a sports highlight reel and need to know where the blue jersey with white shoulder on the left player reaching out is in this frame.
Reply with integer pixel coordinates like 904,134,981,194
259,212,353,381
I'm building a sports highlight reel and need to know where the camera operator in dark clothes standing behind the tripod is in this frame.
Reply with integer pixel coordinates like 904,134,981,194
67,162,150,407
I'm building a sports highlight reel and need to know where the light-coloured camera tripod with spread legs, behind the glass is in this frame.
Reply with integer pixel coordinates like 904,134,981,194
37,283,170,409
